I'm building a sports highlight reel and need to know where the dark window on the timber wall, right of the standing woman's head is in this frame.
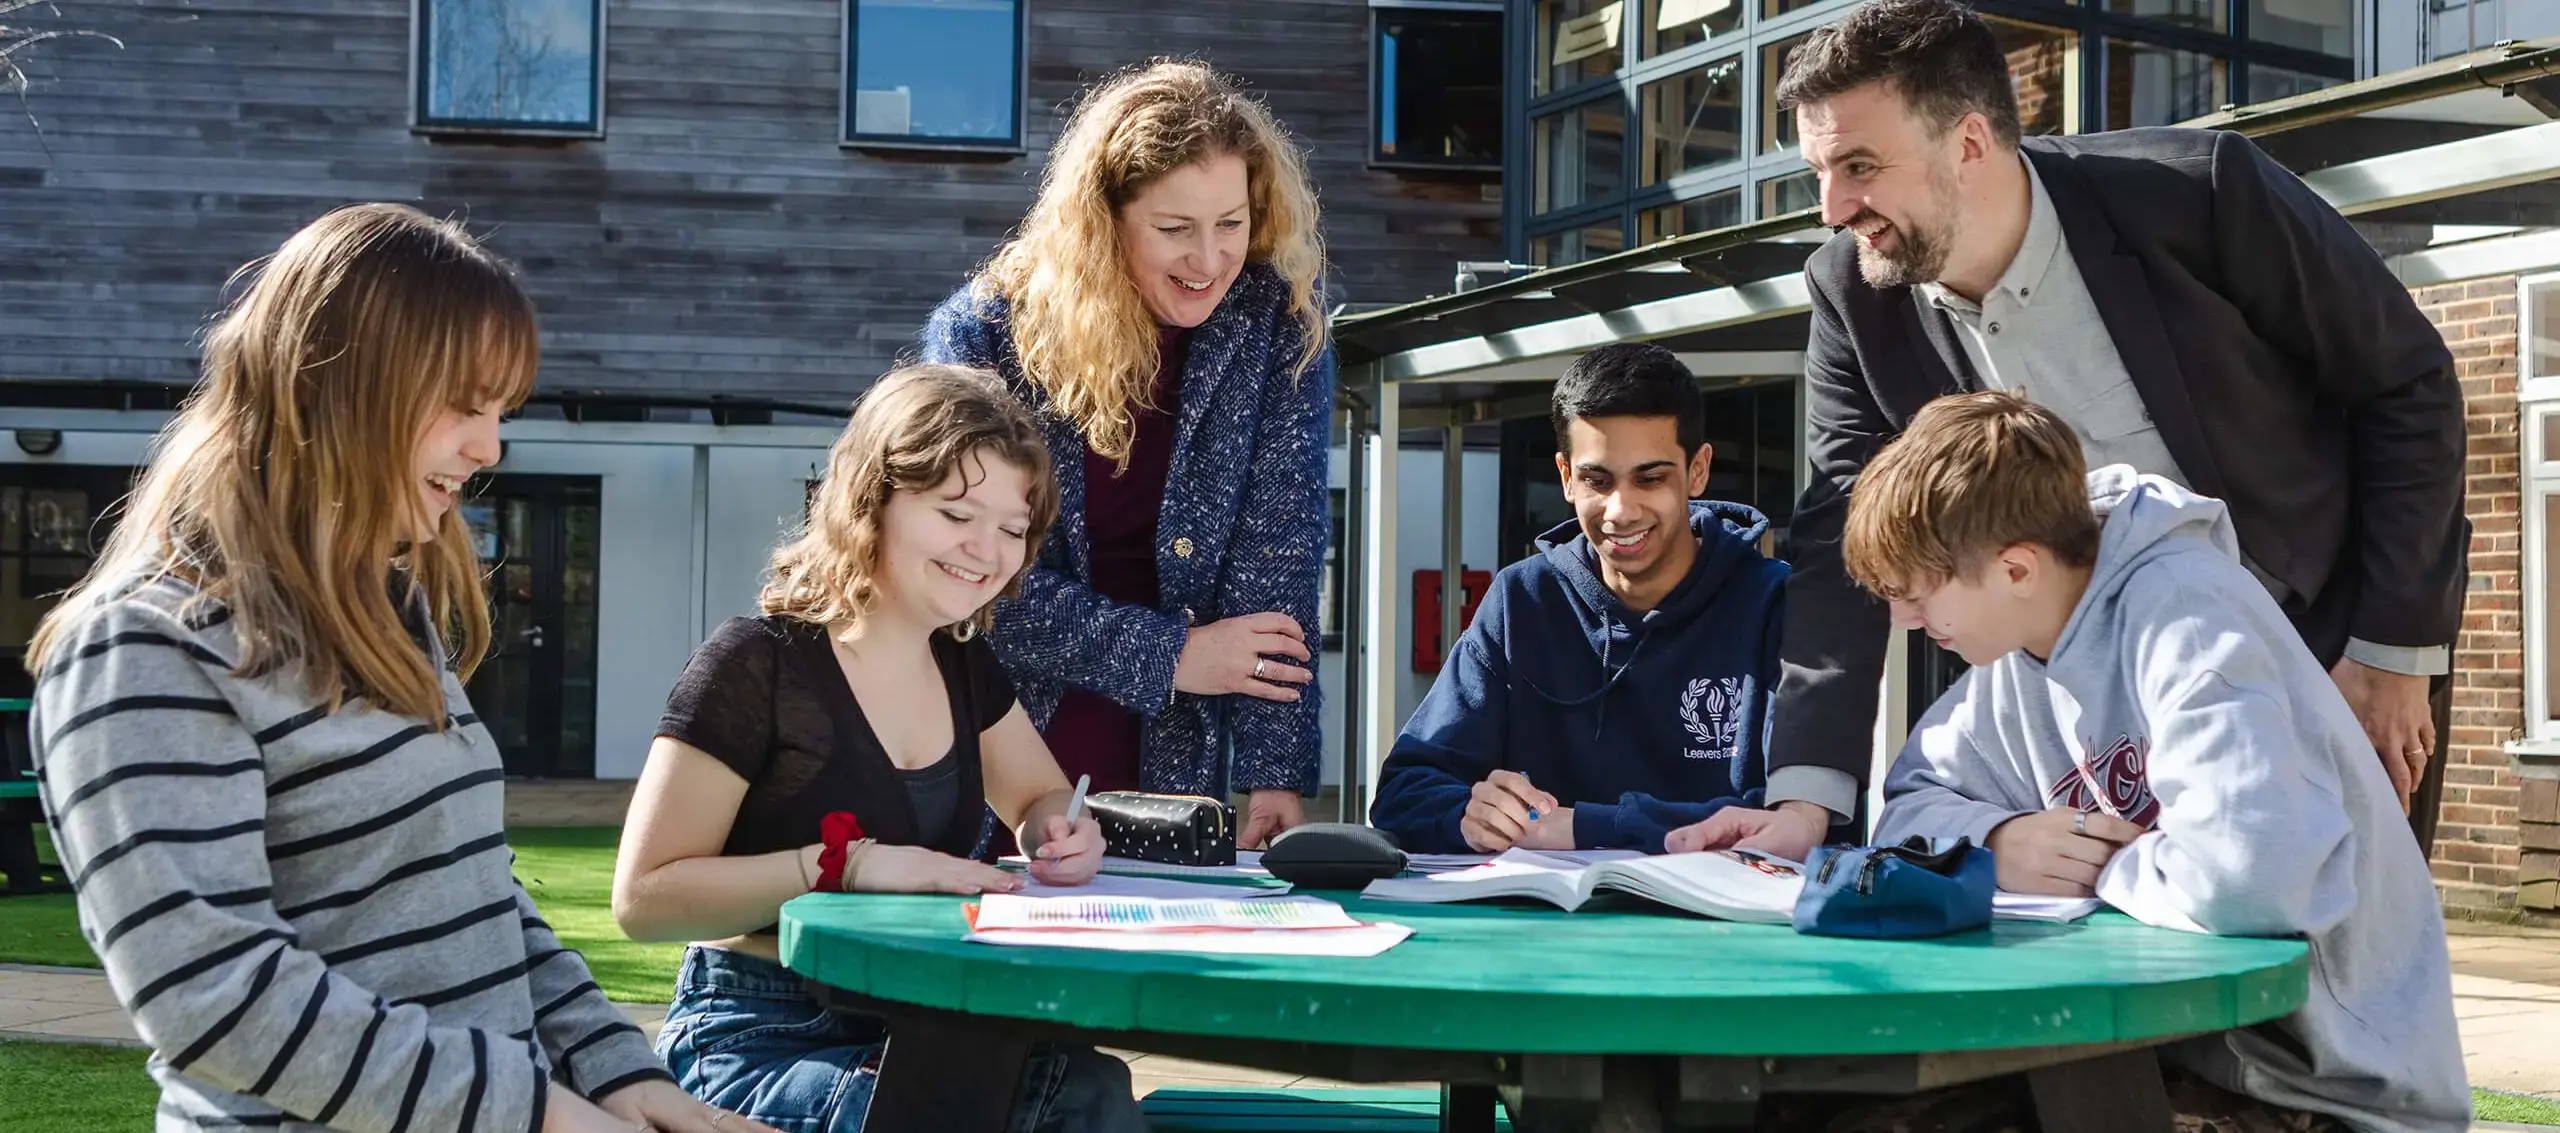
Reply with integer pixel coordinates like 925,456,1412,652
1375,8,1503,169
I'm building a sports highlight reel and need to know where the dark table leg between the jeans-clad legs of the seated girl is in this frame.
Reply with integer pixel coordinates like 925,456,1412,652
863,1015,1032,1133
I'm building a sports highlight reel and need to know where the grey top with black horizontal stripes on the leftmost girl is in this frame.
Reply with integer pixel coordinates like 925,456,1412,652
31,581,668,1133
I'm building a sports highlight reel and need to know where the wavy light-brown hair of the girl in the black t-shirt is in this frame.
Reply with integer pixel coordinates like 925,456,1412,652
758,363,1057,637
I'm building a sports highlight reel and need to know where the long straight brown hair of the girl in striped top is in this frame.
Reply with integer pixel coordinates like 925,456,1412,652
28,205,540,726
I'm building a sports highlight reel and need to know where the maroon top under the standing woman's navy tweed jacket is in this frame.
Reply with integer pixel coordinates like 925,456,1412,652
1044,327,1190,790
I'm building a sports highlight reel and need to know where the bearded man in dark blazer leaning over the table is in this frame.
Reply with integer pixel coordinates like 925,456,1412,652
1674,0,2470,859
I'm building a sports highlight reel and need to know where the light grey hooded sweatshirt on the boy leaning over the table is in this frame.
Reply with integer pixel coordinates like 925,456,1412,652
1876,465,2470,1133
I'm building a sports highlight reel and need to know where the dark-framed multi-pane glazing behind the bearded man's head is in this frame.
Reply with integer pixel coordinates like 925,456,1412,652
1495,0,2355,266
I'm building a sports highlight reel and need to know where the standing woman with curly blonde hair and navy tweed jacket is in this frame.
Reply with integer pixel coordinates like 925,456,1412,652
924,59,1334,847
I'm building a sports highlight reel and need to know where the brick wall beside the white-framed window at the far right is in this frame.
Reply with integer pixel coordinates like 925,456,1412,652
2412,276,2560,913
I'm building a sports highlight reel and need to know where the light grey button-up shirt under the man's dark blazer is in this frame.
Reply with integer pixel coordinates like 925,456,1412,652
1917,156,2452,675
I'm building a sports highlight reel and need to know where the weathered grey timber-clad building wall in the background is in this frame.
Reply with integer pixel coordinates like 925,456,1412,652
0,0,1500,402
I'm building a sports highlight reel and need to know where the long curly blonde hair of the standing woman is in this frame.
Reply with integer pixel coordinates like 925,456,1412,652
980,59,1326,460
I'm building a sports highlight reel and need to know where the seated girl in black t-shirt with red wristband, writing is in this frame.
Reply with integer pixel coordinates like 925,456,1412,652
614,366,1144,1133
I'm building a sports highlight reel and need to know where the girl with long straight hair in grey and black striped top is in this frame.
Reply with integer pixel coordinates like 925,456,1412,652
28,205,768,1133
